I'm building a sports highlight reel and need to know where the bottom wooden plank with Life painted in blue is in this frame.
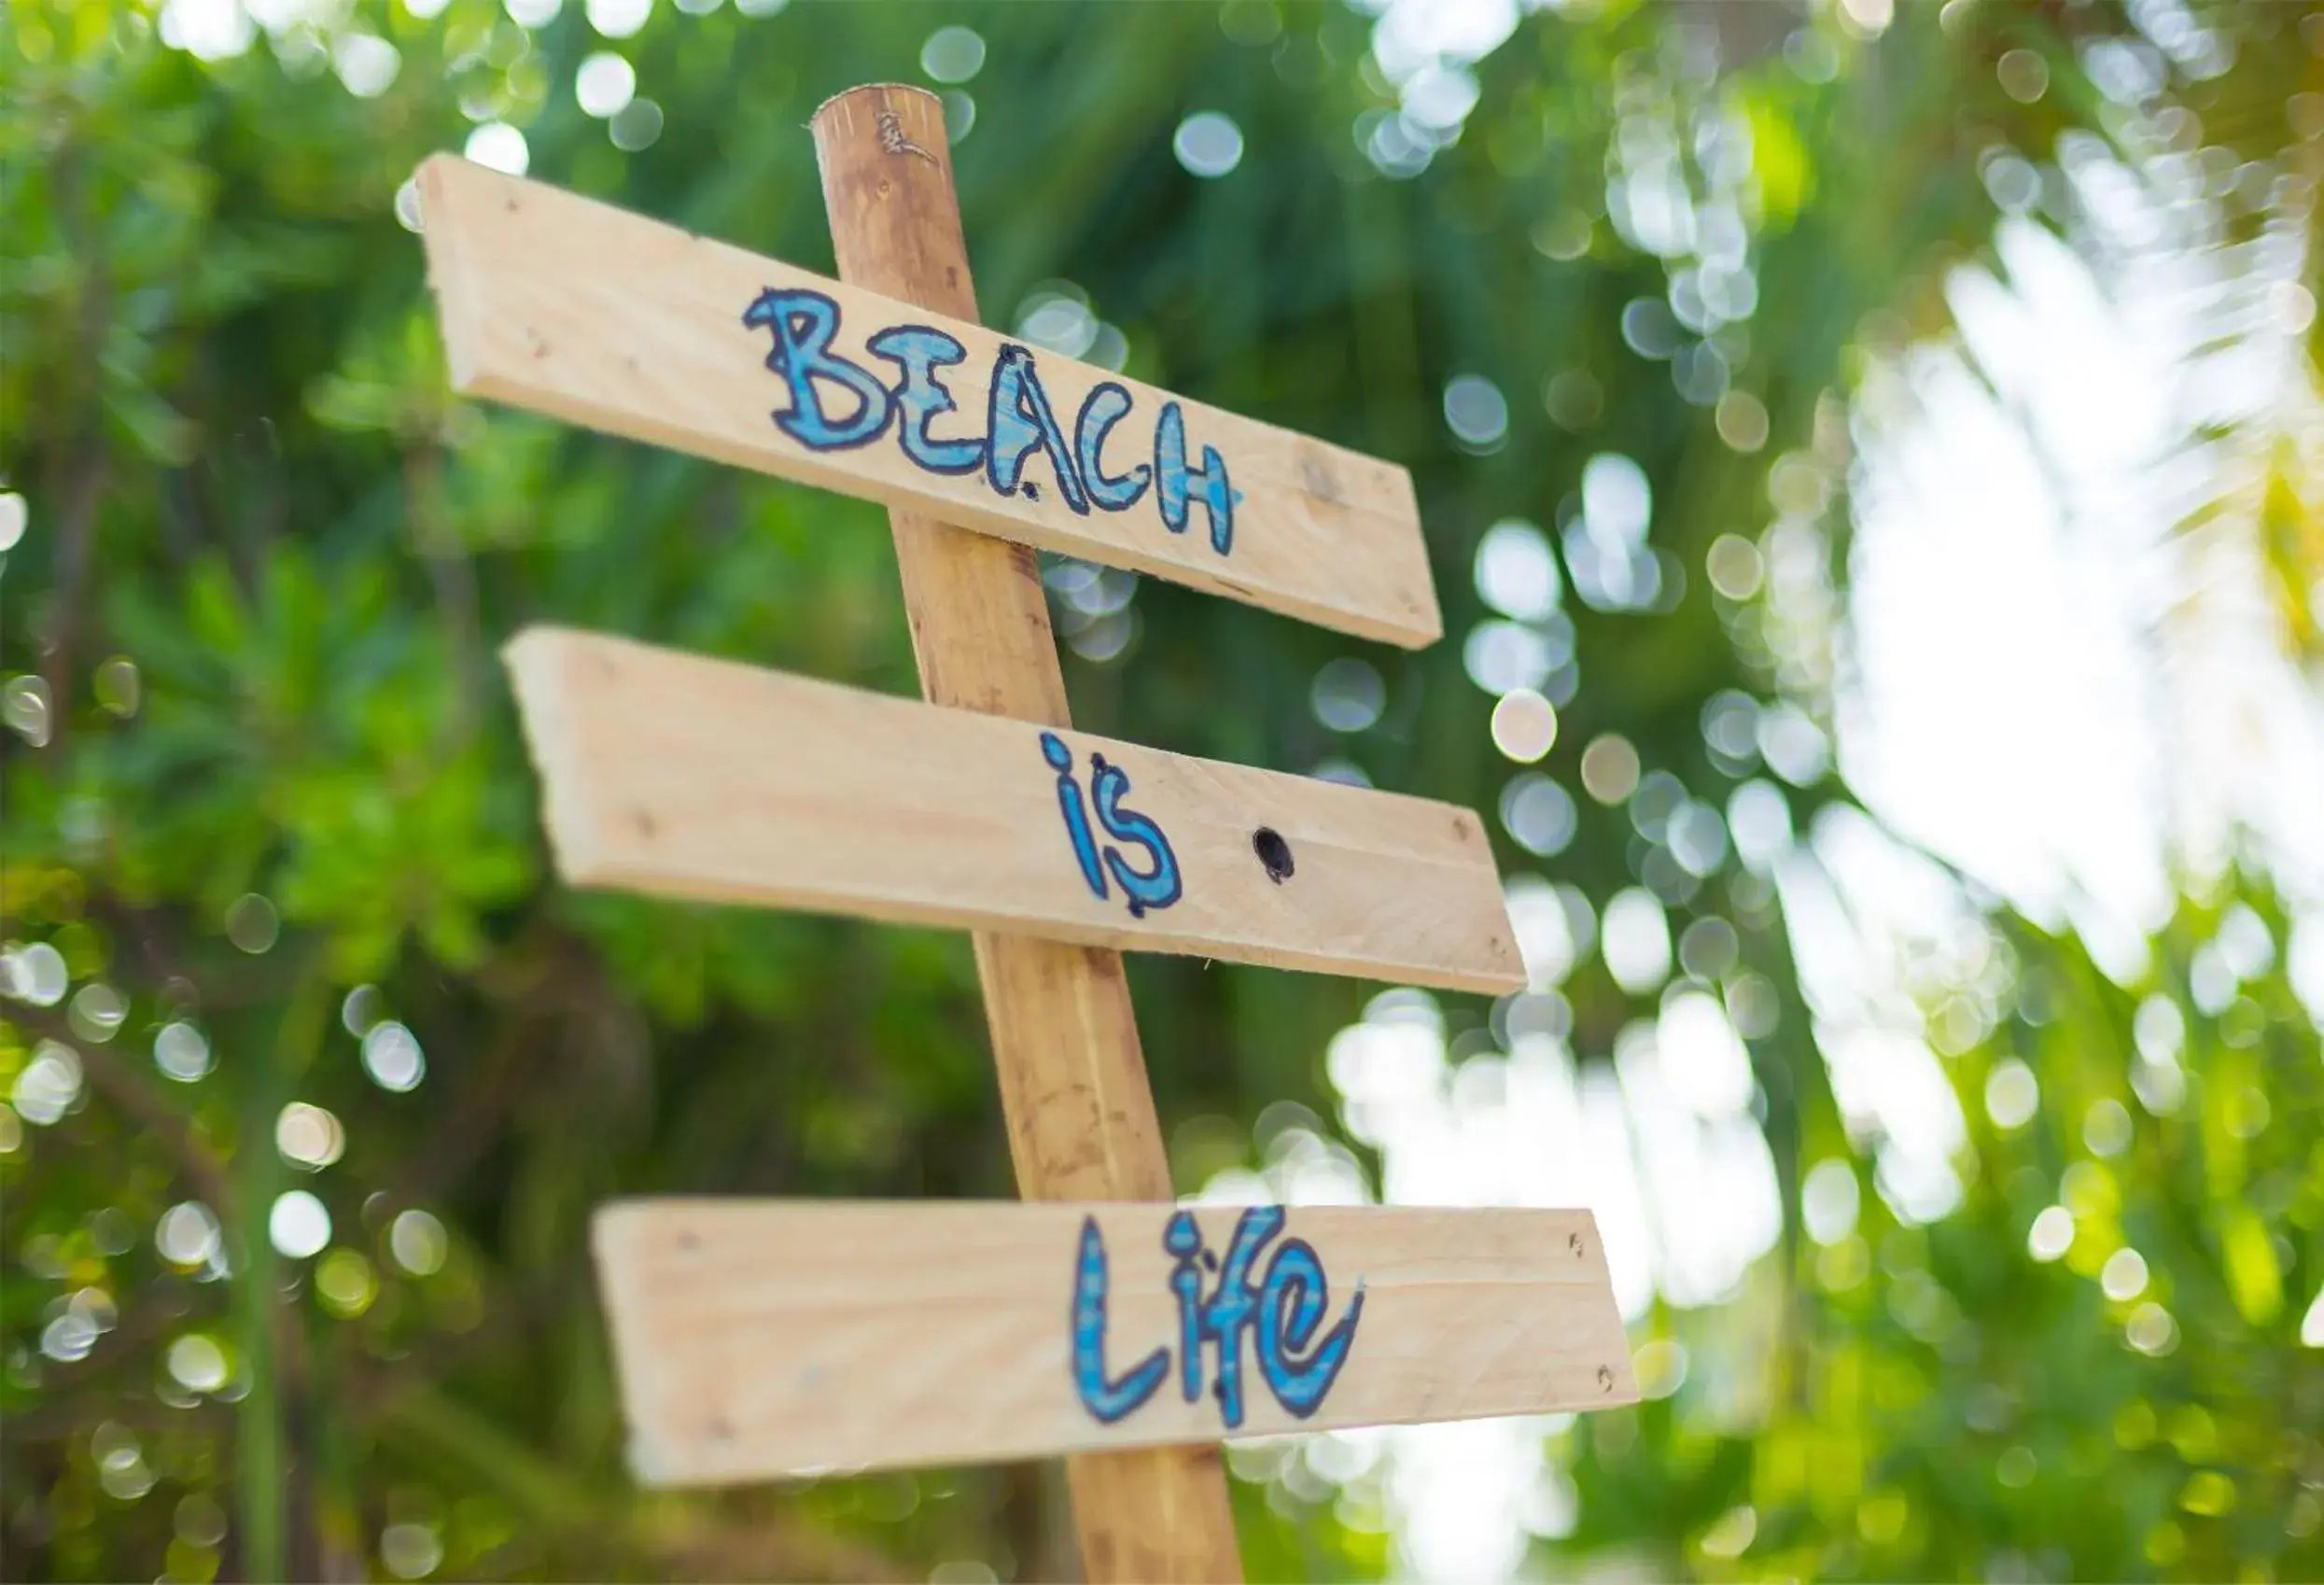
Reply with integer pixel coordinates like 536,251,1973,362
595,1199,1638,1485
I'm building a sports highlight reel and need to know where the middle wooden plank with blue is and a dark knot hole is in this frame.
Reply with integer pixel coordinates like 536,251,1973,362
507,627,1524,992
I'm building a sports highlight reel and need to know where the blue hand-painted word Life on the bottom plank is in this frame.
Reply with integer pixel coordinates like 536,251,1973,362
1073,1206,1365,1432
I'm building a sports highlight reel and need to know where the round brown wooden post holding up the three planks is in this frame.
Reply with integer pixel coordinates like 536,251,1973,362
814,84,1243,1583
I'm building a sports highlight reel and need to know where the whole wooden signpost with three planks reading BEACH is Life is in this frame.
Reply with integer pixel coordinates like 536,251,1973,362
421,86,1636,1580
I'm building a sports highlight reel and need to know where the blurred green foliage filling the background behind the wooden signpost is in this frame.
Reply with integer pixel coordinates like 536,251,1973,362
0,0,2324,1580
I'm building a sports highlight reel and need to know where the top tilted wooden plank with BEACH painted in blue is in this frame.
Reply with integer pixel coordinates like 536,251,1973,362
418,153,1443,649
